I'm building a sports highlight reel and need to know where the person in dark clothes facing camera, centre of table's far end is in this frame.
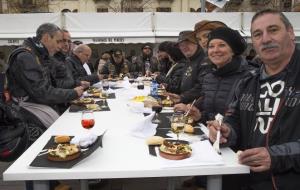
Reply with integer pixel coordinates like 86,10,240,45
130,44,158,77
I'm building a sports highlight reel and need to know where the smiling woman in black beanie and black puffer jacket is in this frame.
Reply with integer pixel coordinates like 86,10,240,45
175,28,252,123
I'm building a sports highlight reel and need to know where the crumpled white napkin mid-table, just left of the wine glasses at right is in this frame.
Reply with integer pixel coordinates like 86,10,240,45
129,112,157,138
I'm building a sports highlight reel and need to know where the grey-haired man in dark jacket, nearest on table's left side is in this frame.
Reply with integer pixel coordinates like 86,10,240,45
7,23,83,127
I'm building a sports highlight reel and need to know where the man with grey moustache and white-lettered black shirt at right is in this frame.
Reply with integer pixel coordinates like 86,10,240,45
208,9,300,190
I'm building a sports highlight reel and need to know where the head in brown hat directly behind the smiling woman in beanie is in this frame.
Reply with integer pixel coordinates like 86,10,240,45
194,20,227,51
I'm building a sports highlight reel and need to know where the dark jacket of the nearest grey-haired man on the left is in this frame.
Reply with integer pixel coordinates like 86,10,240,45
7,38,78,106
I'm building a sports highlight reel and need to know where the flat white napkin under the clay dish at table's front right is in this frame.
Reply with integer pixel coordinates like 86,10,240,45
156,141,224,168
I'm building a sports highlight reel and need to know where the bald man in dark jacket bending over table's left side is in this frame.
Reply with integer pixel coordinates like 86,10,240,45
66,44,103,85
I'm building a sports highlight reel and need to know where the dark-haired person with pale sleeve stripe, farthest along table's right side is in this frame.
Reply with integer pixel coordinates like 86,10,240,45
154,41,186,93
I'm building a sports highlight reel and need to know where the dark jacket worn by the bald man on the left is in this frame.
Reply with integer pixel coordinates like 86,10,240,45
66,54,99,85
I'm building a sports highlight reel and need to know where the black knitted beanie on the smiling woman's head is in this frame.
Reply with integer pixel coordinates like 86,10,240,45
207,28,247,55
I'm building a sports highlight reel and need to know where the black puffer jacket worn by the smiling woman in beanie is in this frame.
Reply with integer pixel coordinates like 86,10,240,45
195,57,253,123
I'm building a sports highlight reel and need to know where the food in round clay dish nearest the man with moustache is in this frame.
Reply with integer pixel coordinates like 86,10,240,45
159,140,192,160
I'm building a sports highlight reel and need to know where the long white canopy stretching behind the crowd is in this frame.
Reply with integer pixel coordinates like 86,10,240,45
0,12,300,46
